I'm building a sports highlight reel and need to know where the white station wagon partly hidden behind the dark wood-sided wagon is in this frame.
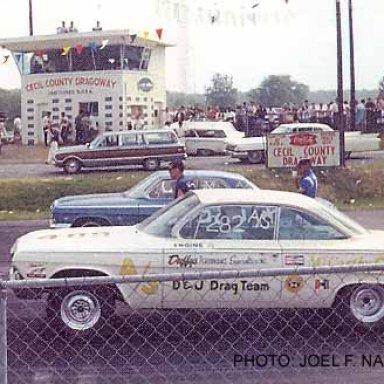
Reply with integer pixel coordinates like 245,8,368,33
171,121,244,156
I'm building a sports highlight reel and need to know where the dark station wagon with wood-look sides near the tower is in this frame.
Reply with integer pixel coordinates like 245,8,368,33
54,129,186,173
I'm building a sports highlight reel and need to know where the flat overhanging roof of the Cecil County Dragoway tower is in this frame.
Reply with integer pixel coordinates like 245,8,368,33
0,29,172,52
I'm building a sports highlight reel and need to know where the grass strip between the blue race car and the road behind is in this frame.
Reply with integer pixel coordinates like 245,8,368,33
0,164,384,220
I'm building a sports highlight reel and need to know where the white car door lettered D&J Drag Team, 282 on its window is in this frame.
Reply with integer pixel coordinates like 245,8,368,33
163,204,282,308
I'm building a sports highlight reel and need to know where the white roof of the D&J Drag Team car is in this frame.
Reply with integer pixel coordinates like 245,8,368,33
192,189,319,209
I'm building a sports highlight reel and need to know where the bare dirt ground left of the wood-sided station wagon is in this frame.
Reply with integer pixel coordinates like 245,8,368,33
0,144,48,165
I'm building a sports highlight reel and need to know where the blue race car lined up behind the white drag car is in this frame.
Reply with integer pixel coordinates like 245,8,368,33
50,170,258,228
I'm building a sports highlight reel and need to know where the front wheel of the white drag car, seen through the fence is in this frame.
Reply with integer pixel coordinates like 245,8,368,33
61,291,101,331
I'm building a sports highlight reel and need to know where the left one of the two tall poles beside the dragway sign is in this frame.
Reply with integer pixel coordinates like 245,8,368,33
336,0,345,167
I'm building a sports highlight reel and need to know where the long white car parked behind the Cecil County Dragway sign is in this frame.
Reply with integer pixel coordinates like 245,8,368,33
227,123,382,164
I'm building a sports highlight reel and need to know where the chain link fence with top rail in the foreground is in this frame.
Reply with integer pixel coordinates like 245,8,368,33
0,265,384,384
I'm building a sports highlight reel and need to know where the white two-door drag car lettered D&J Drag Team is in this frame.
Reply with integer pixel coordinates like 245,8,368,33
11,190,384,332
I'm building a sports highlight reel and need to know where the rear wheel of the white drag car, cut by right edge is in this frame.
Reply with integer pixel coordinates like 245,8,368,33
350,286,384,323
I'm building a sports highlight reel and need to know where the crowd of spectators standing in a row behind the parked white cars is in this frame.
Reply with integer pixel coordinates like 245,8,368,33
164,98,384,136
